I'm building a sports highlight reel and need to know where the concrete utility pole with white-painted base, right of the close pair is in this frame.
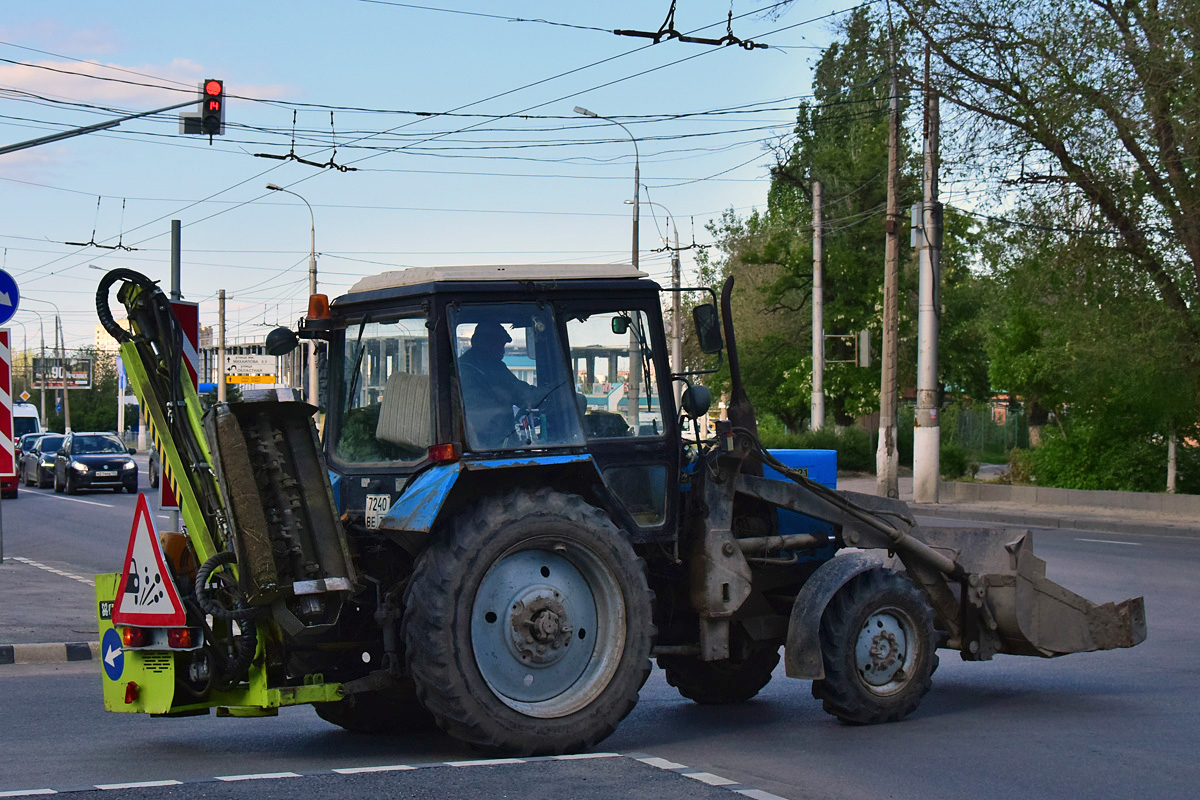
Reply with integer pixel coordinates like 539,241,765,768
912,62,942,503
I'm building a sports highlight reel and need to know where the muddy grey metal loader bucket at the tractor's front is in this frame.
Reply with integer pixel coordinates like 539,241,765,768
911,528,1146,658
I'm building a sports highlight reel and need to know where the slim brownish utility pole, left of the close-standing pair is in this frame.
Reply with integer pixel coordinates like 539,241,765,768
875,64,900,498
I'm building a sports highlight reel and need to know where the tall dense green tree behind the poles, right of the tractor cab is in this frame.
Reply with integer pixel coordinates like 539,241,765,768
706,8,914,428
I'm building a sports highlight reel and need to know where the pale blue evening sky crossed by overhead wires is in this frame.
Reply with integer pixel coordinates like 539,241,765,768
0,0,856,350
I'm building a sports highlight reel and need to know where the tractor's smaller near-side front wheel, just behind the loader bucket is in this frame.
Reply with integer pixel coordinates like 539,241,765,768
812,567,937,724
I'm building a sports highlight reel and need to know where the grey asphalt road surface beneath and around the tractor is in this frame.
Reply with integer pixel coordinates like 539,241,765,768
0,479,1200,800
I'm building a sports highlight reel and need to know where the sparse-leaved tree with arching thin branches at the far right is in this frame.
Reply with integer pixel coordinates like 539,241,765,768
899,0,1200,429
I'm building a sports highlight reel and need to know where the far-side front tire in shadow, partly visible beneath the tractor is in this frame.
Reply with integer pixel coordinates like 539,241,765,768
659,642,779,705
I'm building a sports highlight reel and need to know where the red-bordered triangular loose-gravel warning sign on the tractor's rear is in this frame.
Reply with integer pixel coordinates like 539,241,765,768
113,494,187,627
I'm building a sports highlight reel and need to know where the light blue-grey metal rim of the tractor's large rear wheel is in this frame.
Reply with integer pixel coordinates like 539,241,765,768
470,543,625,717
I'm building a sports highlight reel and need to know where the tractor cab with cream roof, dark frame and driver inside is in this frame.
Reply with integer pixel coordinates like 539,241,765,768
300,265,680,541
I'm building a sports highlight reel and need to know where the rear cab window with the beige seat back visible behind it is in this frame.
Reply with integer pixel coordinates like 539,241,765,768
329,313,433,463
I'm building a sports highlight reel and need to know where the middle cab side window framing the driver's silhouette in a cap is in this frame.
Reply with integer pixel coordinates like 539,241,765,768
449,303,584,450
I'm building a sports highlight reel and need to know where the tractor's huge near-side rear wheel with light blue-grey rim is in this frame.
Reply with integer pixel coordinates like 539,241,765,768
403,489,654,754
